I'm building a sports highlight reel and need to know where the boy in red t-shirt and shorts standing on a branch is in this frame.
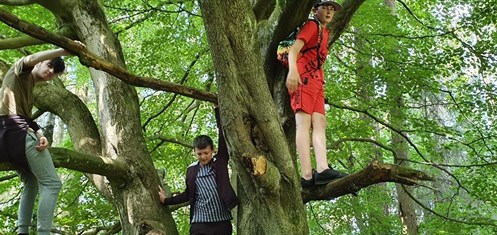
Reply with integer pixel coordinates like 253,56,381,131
286,0,346,188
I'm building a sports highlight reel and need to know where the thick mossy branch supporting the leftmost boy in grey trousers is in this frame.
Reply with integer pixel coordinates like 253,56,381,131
0,148,128,178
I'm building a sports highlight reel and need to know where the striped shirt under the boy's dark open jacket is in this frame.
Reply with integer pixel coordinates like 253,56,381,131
191,164,233,223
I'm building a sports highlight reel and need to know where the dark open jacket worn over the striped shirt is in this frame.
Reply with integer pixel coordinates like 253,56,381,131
164,108,240,219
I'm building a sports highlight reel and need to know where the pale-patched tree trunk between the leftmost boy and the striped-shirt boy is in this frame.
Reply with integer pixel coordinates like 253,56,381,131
40,0,177,234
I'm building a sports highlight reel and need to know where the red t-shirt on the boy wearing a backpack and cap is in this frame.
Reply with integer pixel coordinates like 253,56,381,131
297,20,329,82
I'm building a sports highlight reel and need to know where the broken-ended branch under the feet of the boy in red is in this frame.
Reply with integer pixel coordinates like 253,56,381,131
302,161,433,202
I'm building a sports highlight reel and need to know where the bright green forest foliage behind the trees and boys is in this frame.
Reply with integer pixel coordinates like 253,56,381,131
0,0,497,234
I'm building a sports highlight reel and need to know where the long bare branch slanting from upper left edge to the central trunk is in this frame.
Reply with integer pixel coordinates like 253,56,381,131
0,10,217,103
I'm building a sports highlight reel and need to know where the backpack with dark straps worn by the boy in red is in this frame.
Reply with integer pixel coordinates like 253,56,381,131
276,19,323,69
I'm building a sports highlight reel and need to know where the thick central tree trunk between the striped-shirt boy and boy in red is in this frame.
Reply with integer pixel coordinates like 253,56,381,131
199,0,308,235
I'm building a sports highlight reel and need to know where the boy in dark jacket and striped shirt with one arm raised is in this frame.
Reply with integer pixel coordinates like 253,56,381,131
159,108,239,235
